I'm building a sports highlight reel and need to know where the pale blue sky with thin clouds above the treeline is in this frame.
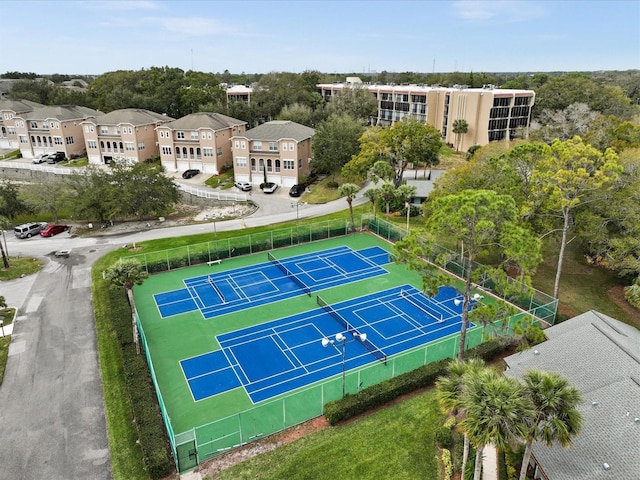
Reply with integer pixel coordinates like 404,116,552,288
0,0,640,75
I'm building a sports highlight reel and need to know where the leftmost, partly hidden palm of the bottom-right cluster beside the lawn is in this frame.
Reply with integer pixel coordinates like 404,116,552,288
436,358,485,476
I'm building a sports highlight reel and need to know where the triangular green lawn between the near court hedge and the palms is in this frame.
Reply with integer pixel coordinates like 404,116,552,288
216,389,444,480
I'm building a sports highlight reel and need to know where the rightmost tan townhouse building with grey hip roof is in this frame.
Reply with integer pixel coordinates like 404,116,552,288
231,120,315,187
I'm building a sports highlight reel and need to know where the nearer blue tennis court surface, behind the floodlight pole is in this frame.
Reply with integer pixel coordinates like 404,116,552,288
180,285,474,403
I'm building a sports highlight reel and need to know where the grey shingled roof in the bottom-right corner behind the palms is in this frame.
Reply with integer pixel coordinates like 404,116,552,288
505,311,640,480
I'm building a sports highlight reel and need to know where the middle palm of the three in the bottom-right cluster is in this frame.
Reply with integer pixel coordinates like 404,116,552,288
460,368,535,480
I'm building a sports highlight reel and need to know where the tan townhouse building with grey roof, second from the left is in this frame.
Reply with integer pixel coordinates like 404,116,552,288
14,105,101,158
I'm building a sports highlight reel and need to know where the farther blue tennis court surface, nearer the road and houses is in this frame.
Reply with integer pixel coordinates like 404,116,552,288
153,247,389,318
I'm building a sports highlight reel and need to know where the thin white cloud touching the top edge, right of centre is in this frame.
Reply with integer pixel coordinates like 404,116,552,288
453,0,545,23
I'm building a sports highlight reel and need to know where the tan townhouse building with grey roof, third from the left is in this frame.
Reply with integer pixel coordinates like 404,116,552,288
82,108,173,165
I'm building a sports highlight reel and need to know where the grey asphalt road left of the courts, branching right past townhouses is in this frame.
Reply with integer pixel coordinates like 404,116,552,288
0,189,367,480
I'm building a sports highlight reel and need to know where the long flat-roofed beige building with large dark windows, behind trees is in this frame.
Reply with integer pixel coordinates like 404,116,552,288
318,77,535,151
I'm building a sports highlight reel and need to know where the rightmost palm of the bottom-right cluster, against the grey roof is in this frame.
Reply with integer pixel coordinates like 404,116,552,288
520,370,582,480
